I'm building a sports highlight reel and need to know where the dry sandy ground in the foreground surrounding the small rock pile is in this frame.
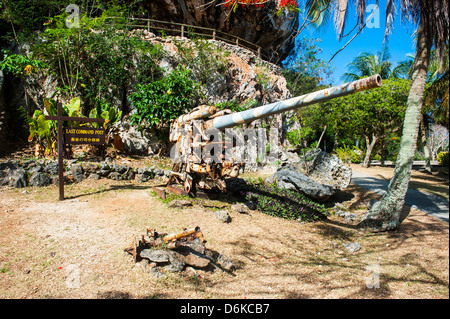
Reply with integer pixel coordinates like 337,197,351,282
0,179,449,298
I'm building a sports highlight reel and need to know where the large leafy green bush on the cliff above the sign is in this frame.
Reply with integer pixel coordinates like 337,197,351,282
31,11,163,107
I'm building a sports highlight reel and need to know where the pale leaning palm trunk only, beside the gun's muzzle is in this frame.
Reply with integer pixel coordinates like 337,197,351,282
358,13,432,231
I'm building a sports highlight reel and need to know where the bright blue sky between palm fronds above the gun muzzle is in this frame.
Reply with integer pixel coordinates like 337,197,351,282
299,0,415,85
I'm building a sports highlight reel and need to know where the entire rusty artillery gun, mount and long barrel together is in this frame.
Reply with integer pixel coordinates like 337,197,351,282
167,74,382,195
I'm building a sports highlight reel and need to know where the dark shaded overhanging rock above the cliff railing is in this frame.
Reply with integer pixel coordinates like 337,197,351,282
142,0,299,63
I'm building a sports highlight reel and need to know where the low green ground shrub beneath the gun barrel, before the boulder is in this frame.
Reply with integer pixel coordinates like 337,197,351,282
241,184,328,221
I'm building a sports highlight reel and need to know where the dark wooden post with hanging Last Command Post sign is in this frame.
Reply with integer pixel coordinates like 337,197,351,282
45,102,105,200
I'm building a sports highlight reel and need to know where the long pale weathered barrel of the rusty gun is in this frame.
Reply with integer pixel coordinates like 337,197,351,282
205,74,382,130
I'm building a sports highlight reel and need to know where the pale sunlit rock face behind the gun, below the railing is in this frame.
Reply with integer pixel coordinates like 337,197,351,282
115,30,291,155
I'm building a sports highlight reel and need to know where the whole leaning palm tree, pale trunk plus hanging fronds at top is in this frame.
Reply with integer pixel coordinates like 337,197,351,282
306,0,449,231
